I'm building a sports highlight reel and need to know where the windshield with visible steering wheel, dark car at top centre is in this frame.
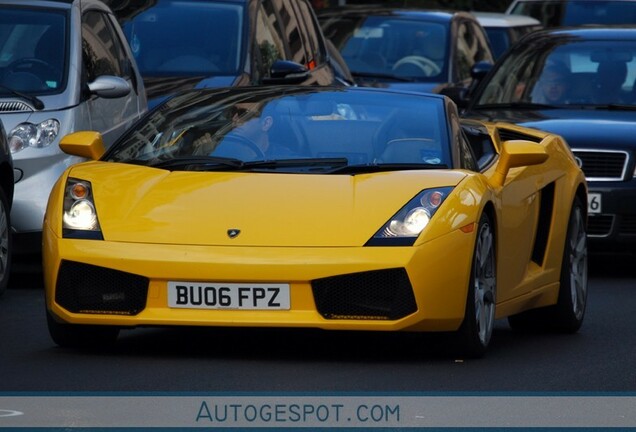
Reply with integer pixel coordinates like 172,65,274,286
323,16,449,82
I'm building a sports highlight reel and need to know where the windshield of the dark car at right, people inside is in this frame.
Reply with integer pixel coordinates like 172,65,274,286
473,38,636,108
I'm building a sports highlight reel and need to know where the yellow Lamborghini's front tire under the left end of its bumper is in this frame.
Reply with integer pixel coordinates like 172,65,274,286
46,310,119,349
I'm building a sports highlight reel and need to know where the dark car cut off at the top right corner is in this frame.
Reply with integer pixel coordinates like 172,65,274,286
506,0,636,27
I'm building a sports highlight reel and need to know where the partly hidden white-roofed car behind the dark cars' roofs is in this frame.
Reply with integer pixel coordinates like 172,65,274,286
472,11,543,59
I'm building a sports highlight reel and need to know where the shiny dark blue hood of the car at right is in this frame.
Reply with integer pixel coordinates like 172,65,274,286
465,109,636,148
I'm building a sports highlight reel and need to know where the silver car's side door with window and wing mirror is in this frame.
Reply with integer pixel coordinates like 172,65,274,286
82,10,145,145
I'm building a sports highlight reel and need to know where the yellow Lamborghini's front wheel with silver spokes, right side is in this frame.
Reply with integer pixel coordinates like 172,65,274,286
457,213,497,358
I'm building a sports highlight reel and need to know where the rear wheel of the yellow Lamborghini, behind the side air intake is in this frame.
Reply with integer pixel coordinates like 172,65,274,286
508,198,588,333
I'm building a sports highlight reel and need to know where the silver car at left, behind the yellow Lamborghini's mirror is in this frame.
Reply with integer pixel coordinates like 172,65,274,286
0,0,147,253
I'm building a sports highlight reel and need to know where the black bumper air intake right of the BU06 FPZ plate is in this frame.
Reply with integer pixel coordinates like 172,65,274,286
311,268,417,320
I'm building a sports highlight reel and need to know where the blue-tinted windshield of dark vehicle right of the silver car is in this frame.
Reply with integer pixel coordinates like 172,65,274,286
120,0,244,77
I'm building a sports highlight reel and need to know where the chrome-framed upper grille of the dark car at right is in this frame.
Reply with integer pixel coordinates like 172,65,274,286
572,149,629,181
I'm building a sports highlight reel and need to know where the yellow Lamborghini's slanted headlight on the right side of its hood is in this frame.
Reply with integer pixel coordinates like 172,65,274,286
367,187,453,246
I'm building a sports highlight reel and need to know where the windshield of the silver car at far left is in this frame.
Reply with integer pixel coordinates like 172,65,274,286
0,6,68,96
